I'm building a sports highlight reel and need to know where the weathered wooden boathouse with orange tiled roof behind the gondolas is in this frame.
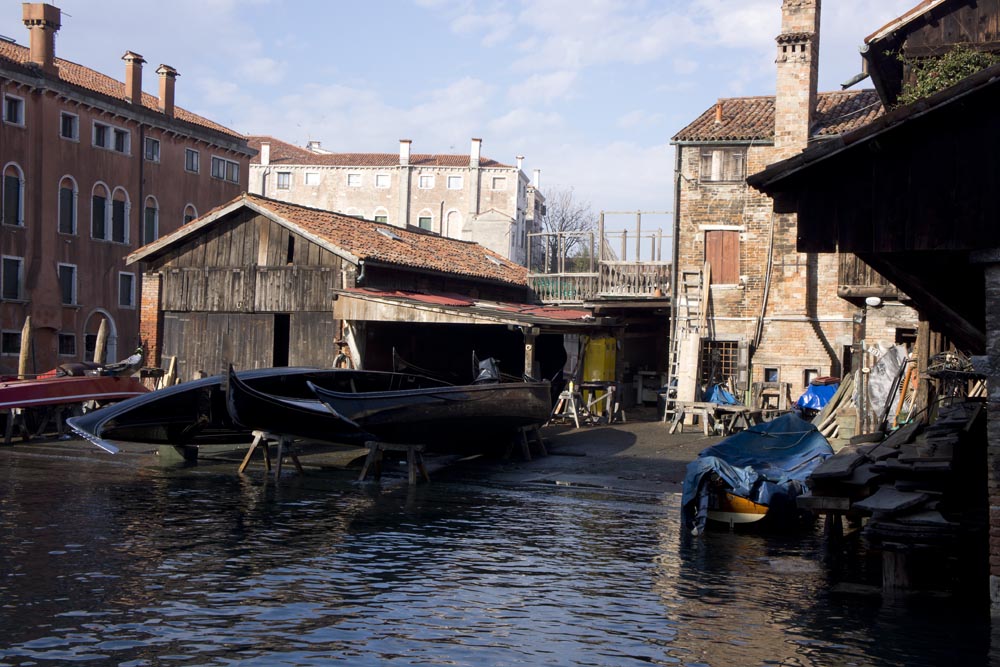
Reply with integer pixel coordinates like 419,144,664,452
127,194,608,380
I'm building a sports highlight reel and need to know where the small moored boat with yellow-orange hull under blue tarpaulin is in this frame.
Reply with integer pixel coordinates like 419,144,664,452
681,413,833,535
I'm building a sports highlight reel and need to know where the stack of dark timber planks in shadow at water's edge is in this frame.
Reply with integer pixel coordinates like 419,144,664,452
799,401,986,552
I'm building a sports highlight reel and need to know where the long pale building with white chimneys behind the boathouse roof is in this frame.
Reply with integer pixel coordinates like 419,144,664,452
249,136,539,264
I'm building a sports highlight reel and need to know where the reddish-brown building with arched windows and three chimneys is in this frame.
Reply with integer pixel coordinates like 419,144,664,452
0,3,252,374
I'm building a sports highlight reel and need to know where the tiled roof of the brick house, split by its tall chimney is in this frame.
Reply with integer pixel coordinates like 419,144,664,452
673,90,883,142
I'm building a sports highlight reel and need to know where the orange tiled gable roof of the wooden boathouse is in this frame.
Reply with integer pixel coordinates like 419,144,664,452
128,194,528,285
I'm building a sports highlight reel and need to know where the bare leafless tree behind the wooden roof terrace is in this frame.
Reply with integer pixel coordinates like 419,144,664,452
542,187,597,272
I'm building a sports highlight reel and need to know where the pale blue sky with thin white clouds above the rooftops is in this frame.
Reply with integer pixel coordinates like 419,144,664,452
0,0,918,226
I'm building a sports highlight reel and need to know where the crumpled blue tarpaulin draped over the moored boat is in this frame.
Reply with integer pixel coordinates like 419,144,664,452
681,412,833,534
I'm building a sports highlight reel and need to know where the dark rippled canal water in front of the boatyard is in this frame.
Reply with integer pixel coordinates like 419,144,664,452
0,447,990,667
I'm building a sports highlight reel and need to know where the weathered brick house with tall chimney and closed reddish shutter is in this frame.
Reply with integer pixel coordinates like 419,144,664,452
671,0,917,400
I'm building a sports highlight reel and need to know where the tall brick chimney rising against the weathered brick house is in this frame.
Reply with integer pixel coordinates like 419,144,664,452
774,0,820,161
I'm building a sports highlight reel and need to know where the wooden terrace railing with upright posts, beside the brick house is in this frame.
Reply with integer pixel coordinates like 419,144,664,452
528,212,671,303
